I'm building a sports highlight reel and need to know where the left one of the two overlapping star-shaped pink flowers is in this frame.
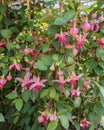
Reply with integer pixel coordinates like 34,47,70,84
16,72,33,88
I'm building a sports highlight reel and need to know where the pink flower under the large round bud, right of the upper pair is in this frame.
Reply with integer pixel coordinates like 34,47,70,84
75,34,87,47
